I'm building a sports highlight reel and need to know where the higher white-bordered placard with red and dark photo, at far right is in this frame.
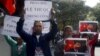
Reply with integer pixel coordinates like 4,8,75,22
79,21,98,33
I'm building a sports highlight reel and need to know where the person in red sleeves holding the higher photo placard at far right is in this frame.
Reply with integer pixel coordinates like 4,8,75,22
82,34,98,56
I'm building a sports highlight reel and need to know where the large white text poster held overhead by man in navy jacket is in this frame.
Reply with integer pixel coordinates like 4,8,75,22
25,1,52,20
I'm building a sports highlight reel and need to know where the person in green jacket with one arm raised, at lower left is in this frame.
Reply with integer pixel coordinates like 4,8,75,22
5,36,26,56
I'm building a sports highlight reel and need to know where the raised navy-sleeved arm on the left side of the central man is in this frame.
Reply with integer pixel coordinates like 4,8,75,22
16,18,30,42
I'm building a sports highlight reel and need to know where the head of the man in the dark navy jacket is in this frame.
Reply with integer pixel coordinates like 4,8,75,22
33,21,43,34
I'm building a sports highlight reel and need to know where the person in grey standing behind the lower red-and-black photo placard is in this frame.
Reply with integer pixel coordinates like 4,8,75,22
55,25,76,56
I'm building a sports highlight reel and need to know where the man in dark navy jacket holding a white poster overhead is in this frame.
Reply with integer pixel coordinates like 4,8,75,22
16,19,58,56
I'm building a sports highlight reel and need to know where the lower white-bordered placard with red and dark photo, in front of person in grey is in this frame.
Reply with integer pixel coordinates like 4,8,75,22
64,38,88,56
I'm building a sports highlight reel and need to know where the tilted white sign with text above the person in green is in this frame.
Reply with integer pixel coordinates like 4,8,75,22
2,15,20,37
